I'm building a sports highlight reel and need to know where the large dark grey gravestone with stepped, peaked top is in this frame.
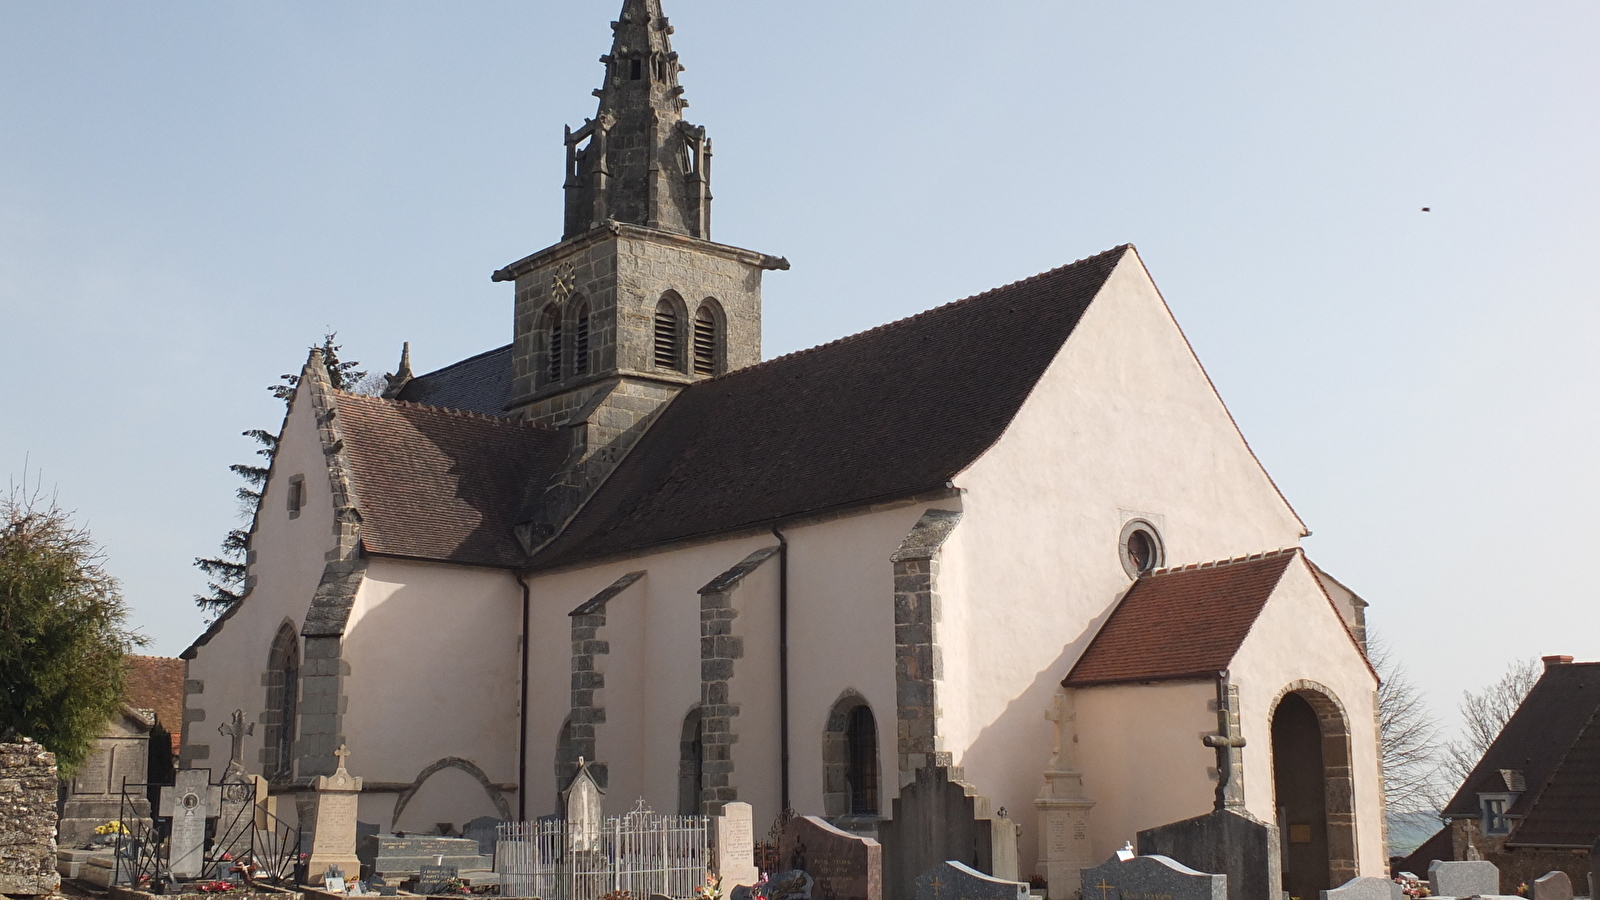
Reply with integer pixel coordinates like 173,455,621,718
878,754,1018,900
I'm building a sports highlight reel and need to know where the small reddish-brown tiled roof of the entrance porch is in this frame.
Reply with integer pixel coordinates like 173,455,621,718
1062,549,1299,687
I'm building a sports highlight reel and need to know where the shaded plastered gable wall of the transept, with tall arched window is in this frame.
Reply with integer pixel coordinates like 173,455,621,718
186,374,334,775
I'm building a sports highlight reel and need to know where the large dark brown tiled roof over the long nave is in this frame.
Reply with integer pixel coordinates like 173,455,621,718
534,247,1130,567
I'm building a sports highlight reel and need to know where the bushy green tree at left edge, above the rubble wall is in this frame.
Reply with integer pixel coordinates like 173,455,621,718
0,477,144,777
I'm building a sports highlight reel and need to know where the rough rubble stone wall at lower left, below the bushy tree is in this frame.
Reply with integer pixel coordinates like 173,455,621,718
0,741,61,895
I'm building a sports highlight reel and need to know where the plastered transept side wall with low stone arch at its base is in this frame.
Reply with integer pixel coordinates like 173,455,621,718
342,557,522,831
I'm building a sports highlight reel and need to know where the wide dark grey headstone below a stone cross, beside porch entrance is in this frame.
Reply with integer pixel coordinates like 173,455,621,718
1139,807,1283,900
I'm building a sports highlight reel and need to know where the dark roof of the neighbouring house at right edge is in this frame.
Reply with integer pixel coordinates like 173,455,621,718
1443,663,1600,818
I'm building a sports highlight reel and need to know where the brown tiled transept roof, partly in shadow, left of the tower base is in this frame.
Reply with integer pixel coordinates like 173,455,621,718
336,392,566,567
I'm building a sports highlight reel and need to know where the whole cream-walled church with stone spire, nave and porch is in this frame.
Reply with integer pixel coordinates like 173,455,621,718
182,0,1387,897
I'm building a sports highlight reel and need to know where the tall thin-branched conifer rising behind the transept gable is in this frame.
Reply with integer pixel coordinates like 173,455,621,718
195,331,366,615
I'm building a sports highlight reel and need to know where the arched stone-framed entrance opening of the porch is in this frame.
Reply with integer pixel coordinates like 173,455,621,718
1272,682,1357,900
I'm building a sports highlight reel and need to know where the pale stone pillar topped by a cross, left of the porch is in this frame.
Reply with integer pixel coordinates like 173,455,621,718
1034,689,1094,900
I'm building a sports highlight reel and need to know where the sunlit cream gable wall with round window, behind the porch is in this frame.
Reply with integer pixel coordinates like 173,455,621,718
939,253,1304,873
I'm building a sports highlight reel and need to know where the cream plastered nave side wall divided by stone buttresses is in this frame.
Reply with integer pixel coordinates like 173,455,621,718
528,500,934,831
